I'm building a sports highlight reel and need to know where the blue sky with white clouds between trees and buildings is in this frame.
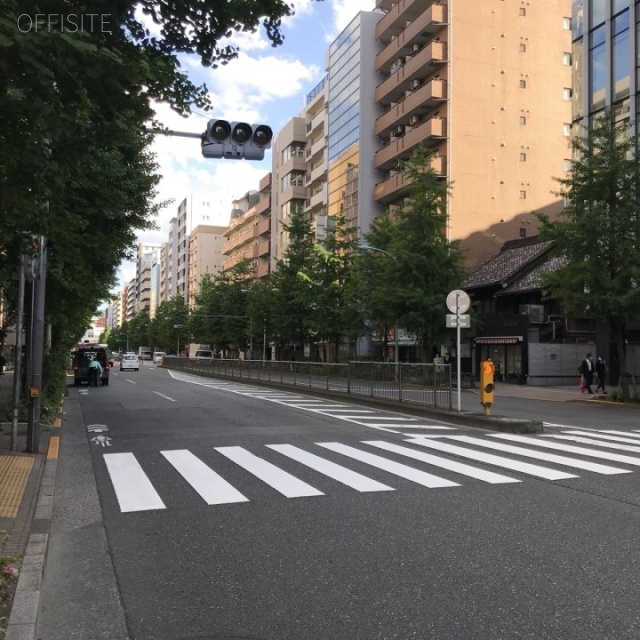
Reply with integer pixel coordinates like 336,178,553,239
118,0,375,288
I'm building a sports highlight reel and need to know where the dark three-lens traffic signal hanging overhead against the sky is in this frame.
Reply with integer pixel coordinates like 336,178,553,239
202,120,273,160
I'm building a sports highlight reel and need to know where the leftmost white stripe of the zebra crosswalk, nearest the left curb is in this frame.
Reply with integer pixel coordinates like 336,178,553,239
103,453,166,513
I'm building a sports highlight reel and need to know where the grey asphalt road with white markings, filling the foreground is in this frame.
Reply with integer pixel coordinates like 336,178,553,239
38,366,640,640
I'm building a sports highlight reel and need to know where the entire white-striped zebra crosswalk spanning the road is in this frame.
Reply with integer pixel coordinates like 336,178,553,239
103,429,640,513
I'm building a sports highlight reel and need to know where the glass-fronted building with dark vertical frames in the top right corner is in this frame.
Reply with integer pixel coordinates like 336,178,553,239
567,0,640,127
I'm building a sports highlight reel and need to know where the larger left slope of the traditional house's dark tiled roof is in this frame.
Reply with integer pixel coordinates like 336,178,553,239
462,238,552,290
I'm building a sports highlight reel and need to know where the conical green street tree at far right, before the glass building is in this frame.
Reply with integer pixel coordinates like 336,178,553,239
538,109,640,399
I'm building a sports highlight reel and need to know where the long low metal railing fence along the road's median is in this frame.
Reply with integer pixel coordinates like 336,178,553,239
164,358,452,409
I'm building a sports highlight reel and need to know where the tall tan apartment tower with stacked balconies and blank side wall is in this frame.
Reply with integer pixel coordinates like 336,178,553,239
374,0,572,266
